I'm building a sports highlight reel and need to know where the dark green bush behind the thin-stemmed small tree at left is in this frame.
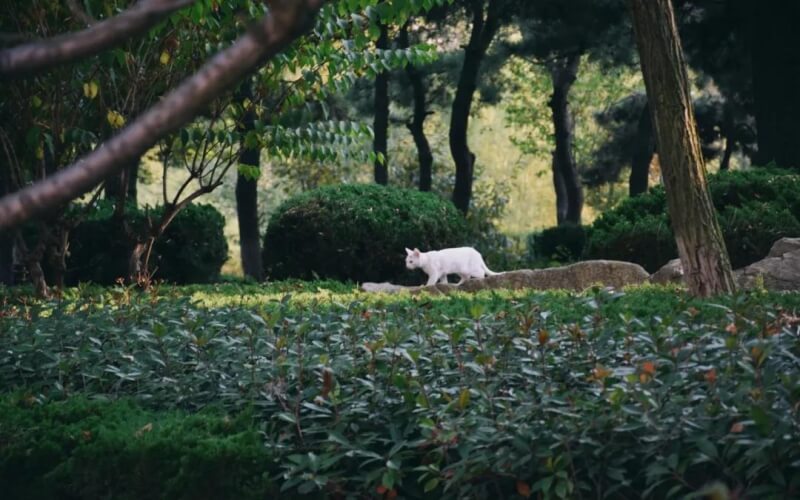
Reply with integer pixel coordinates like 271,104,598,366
67,203,228,285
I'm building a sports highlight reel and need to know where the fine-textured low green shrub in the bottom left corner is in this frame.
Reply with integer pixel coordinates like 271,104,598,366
0,396,278,500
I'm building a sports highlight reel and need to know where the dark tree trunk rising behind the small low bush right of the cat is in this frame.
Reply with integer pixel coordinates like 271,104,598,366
549,53,583,225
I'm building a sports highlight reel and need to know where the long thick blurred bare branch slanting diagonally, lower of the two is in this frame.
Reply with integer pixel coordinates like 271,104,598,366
0,0,325,228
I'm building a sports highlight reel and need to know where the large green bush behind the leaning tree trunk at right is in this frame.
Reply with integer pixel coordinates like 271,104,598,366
585,168,800,272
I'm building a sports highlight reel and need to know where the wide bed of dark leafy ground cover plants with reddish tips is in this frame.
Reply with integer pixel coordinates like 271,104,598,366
0,282,800,498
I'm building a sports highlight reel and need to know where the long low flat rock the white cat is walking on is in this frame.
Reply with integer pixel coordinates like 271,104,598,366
361,260,650,293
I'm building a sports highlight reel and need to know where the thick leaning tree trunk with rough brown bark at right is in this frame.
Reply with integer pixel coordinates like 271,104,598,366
629,0,735,297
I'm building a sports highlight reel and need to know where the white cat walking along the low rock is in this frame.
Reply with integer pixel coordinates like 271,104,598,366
406,247,500,286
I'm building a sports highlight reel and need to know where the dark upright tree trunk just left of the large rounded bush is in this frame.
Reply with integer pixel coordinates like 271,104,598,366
236,82,264,281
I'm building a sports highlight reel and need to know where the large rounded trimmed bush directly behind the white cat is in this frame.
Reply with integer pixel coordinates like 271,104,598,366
263,185,468,283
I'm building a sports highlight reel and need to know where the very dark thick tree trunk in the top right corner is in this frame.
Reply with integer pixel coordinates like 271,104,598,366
750,0,800,169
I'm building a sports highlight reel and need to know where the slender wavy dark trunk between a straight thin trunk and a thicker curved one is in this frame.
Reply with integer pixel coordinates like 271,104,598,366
398,23,433,191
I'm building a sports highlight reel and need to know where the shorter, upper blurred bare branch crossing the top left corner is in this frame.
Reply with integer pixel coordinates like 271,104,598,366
0,0,195,78
